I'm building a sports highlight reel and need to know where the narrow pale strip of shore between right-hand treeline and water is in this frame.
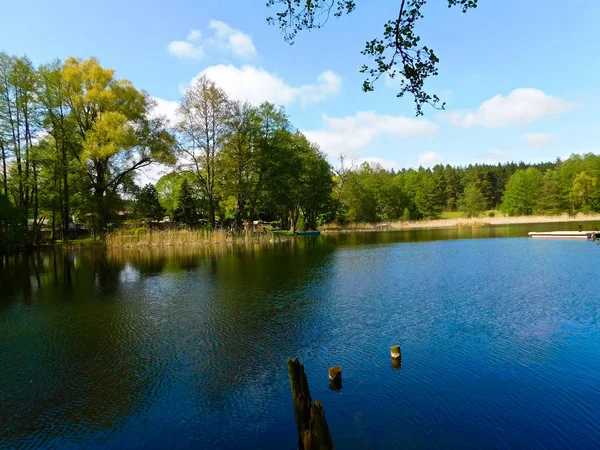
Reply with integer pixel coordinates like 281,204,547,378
321,214,600,233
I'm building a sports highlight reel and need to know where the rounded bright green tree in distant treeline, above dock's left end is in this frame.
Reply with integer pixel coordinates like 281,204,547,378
501,167,544,216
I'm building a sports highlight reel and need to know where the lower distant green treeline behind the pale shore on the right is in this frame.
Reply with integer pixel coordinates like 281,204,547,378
328,154,600,222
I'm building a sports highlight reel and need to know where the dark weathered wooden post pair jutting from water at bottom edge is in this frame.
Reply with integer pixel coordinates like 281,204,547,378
287,358,335,450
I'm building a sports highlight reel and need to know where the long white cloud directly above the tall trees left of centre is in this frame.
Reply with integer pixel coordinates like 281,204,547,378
199,64,342,106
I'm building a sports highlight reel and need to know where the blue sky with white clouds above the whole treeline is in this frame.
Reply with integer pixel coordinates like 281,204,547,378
0,0,600,172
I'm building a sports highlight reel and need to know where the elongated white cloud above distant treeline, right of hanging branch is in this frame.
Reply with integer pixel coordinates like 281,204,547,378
440,88,573,128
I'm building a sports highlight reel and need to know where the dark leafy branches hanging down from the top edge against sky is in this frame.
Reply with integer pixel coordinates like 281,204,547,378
267,0,477,115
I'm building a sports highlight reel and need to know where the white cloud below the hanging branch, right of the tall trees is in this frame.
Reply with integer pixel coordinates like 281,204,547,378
304,111,437,158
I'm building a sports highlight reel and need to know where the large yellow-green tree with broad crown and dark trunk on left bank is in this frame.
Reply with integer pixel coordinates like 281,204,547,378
62,58,174,235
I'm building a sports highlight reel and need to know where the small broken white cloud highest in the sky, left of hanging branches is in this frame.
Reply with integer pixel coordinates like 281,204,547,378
167,20,256,59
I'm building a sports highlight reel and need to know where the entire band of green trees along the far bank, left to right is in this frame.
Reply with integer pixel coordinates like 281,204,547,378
0,53,600,247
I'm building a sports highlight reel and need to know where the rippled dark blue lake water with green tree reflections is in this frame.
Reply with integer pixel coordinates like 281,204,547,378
0,224,600,449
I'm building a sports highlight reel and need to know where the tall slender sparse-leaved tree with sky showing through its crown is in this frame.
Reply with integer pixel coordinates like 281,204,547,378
177,76,229,228
